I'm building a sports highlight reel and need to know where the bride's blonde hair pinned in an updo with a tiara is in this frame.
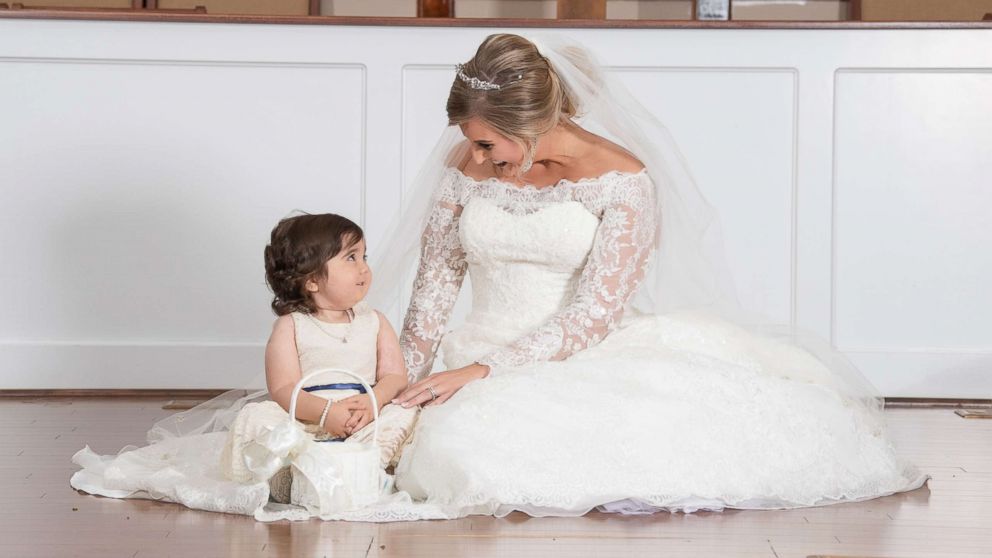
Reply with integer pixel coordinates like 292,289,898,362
447,34,576,151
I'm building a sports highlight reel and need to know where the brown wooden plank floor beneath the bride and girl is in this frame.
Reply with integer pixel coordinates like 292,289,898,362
0,398,992,558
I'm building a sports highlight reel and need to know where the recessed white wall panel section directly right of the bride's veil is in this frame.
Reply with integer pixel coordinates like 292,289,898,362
619,66,798,323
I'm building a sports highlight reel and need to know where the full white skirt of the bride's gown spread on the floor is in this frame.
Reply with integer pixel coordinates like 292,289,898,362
396,315,928,516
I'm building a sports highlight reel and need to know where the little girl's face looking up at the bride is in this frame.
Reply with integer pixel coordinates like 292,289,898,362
306,240,372,310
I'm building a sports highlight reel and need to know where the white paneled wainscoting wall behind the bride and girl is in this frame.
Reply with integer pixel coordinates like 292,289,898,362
0,20,992,397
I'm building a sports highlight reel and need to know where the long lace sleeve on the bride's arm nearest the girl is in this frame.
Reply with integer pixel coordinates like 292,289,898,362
400,173,467,383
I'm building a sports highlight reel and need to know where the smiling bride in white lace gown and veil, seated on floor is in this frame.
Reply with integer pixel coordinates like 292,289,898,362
68,29,928,521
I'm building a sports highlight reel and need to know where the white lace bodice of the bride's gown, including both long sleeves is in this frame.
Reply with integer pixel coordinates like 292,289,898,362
400,169,655,380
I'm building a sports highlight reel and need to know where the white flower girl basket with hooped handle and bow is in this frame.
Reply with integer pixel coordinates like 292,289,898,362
287,368,388,516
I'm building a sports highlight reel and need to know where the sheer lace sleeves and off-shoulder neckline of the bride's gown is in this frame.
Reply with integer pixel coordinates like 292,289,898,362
400,169,655,381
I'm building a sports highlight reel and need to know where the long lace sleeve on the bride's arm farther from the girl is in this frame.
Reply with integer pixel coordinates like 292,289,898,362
479,174,655,374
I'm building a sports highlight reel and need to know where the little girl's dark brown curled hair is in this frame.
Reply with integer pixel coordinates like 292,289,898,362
265,213,365,316
